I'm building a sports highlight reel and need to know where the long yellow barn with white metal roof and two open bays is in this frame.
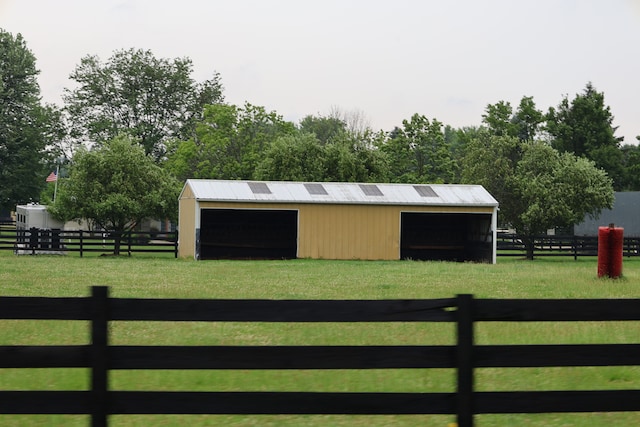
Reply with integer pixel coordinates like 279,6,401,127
178,179,498,263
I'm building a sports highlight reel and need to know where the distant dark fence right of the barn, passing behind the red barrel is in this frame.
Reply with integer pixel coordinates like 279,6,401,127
497,233,640,259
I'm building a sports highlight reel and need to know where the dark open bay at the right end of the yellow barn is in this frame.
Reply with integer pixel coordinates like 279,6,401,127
400,212,493,263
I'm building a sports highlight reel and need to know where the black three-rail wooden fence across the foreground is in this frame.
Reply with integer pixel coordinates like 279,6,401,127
0,287,640,427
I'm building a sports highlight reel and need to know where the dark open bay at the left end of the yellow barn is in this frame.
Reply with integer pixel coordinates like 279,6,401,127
198,209,298,259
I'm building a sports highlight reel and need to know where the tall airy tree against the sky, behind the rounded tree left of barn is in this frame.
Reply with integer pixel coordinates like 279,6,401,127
63,49,223,160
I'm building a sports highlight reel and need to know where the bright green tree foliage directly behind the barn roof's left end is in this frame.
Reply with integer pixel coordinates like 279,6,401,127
165,103,295,179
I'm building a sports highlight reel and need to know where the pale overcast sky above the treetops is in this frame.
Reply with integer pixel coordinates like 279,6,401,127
0,0,640,143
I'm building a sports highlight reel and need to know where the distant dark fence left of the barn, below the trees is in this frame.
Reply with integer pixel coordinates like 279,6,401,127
0,228,178,257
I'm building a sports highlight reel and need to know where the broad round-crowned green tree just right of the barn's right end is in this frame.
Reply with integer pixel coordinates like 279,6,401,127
463,133,613,259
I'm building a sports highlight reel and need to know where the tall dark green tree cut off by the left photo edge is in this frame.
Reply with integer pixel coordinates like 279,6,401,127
0,29,55,210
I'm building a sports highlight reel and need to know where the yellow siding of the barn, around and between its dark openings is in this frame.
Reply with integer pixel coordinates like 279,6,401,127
192,200,493,260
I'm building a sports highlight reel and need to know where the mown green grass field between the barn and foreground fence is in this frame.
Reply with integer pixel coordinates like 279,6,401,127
0,251,640,427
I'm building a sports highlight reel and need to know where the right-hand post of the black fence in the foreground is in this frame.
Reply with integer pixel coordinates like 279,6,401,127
456,294,474,427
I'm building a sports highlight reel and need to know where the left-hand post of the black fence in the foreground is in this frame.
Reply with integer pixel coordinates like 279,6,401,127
90,286,109,427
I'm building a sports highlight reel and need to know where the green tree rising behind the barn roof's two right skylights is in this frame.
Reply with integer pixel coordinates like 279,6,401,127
381,114,457,183
